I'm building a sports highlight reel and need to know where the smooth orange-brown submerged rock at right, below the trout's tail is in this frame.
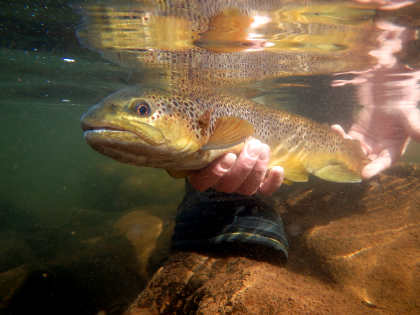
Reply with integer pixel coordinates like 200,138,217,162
304,168,420,314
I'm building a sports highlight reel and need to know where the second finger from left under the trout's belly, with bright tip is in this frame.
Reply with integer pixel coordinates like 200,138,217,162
214,139,262,193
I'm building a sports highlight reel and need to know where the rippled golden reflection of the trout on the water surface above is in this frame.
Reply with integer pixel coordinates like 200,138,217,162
78,0,376,89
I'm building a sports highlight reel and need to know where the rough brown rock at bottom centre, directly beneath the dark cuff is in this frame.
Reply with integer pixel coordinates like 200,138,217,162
126,253,378,315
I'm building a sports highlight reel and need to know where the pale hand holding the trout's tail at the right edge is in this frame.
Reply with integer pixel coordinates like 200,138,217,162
331,107,420,179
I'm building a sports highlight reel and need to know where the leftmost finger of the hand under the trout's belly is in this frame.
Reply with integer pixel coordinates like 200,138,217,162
190,153,237,191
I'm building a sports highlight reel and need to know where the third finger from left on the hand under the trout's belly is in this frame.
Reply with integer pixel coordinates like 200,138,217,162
236,144,270,195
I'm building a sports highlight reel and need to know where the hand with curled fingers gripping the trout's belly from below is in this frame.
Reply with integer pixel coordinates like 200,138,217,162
190,138,284,195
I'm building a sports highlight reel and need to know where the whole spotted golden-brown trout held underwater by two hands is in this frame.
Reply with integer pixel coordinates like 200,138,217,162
81,86,366,183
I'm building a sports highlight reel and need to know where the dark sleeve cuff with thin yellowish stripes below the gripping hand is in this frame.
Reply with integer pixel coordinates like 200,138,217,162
172,181,288,258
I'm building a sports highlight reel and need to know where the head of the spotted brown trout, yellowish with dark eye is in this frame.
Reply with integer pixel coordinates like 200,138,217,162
81,87,203,168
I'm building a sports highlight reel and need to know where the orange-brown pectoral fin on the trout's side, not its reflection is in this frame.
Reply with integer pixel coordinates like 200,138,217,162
201,117,254,150
